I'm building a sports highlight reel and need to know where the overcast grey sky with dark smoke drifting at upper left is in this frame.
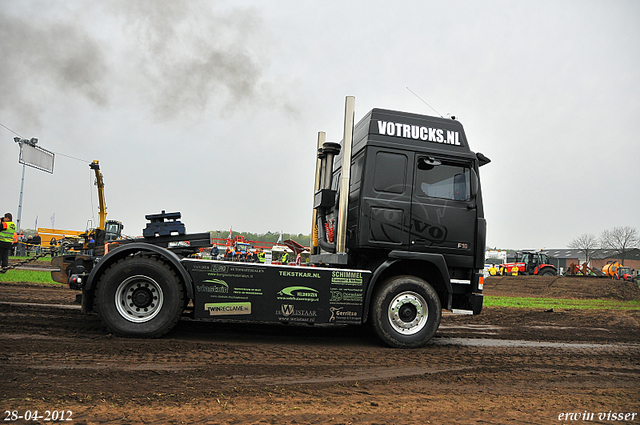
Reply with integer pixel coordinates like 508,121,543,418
0,0,640,249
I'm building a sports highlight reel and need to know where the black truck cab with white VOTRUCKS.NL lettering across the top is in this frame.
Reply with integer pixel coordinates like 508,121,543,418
311,105,489,324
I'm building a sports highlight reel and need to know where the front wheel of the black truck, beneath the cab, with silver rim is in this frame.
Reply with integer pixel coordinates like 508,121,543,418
371,276,442,348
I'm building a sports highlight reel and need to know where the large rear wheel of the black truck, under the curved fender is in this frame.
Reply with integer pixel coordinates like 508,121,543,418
95,256,185,338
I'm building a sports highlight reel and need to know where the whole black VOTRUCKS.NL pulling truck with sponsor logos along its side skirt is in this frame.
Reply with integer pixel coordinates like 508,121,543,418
52,97,490,348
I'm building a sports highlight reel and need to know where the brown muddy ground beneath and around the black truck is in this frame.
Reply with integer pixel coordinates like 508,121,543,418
0,277,640,424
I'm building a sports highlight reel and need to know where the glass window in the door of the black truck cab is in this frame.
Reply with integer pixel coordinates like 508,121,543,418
416,163,471,201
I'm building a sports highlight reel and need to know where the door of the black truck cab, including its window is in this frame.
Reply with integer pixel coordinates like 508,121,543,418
410,155,476,267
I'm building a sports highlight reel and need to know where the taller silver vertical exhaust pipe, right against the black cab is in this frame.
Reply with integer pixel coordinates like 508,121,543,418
336,96,356,253
